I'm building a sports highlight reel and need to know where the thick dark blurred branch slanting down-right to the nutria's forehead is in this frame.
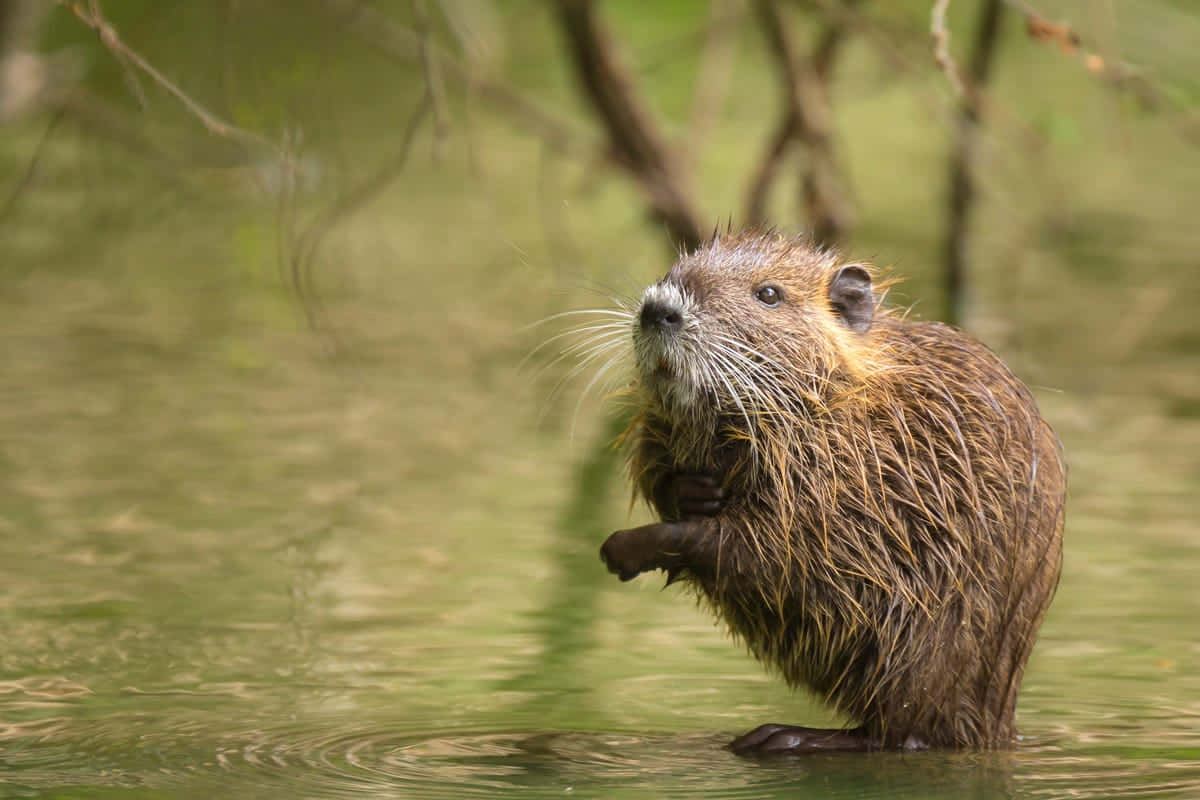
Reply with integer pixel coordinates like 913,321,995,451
558,0,703,249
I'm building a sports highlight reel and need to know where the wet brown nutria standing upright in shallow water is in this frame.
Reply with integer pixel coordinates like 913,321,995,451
601,233,1066,753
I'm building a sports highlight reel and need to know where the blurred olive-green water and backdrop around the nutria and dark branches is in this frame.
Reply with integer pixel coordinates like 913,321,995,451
0,0,1200,798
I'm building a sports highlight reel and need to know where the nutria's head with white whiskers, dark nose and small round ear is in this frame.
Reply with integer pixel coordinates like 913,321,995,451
634,235,876,423
